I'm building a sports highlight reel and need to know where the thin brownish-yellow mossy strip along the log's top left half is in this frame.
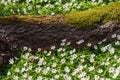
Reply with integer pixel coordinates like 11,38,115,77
0,14,65,25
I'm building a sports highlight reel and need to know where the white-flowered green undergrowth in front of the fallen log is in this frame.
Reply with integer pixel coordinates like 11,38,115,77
0,34,120,80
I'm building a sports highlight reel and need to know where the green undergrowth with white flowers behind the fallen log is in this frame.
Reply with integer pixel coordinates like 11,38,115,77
0,0,119,16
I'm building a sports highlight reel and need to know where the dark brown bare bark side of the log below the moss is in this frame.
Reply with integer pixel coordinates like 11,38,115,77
0,17,120,65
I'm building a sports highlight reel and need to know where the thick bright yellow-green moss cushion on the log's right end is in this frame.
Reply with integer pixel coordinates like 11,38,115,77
65,2,120,28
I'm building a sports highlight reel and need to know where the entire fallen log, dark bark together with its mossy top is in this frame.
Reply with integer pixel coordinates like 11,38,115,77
0,2,120,64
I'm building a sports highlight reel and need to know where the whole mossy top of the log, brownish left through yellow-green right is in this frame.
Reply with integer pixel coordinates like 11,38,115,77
0,2,120,29
